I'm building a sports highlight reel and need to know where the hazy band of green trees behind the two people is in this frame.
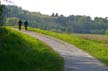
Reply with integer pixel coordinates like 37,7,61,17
6,6,108,34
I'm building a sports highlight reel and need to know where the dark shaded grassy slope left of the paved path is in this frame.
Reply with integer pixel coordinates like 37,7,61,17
0,28,63,71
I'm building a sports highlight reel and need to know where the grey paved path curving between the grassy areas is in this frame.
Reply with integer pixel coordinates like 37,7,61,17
22,31,108,71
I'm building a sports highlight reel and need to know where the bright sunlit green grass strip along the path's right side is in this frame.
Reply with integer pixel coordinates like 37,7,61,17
29,28,108,65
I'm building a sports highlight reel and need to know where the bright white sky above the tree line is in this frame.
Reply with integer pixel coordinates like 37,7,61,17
1,0,108,18
